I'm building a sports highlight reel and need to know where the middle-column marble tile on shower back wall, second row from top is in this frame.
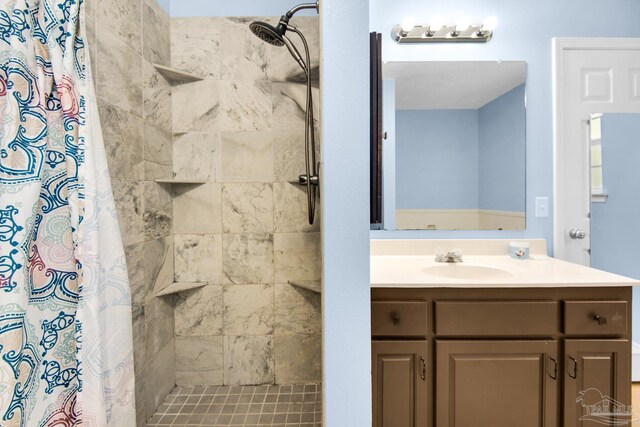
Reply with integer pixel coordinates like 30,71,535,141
220,80,273,131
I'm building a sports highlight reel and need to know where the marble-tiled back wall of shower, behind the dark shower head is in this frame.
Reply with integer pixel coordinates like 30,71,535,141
171,17,321,385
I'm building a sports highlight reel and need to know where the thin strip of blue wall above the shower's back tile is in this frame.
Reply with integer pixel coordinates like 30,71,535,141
170,0,317,17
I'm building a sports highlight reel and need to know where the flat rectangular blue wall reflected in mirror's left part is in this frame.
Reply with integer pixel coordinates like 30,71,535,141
396,110,478,209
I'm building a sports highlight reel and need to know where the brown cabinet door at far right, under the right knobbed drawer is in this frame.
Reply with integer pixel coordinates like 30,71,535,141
564,340,632,427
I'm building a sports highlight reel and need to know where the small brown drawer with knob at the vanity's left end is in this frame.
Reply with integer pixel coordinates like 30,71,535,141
371,301,427,337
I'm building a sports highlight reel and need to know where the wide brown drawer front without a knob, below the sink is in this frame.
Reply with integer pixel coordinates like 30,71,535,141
435,301,560,337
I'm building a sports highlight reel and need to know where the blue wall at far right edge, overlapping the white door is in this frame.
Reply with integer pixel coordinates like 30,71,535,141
591,114,640,343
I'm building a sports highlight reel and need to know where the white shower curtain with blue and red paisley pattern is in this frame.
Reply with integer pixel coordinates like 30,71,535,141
0,0,135,427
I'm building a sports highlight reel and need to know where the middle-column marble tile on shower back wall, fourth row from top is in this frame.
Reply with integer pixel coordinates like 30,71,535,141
222,183,273,233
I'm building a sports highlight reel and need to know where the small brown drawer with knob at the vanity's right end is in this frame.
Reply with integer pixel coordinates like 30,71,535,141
564,301,628,335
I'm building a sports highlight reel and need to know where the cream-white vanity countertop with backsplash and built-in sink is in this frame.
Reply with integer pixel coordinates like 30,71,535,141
371,239,640,288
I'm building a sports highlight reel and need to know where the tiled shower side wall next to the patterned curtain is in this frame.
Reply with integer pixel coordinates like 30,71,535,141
85,0,175,426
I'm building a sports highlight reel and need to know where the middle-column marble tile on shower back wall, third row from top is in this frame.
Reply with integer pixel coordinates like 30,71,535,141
221,132,274,182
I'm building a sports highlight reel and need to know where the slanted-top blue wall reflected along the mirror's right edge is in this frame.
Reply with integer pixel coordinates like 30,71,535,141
478,84,526,212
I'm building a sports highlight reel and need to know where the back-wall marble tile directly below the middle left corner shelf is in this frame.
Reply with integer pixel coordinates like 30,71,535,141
173,183,222,234
